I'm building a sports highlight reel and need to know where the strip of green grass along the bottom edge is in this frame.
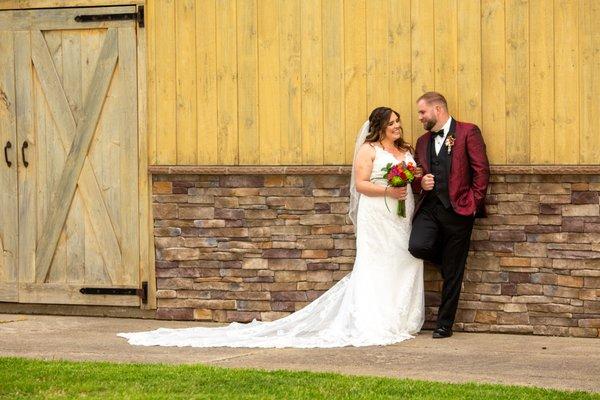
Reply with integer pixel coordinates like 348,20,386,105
0,357,600,400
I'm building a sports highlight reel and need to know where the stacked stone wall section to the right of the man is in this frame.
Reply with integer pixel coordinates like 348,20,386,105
458,175,600,337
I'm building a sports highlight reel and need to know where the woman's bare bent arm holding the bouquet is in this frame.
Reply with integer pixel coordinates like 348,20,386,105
354,143,406,199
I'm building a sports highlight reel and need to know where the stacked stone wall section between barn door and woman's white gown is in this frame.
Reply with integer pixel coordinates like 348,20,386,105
153,175,355,322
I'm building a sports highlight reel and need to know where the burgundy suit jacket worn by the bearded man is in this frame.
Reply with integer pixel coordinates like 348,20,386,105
412,120,490,217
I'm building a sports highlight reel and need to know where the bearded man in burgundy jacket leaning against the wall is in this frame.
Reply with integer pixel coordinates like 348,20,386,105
409,92,490,339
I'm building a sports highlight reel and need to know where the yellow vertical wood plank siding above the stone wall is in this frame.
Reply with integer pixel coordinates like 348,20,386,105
146,0,600,165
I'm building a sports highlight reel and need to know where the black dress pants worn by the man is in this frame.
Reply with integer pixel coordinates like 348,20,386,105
408,193,475,328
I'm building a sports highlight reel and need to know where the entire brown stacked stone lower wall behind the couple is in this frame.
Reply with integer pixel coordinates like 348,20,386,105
152,167,600,337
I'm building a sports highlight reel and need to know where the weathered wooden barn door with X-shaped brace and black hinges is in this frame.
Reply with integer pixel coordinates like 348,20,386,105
0,7,140,305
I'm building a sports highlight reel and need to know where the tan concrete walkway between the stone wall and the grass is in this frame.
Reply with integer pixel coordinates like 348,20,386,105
0,314,600,392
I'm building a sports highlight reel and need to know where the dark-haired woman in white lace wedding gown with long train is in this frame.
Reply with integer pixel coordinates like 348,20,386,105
119,107,425,348
